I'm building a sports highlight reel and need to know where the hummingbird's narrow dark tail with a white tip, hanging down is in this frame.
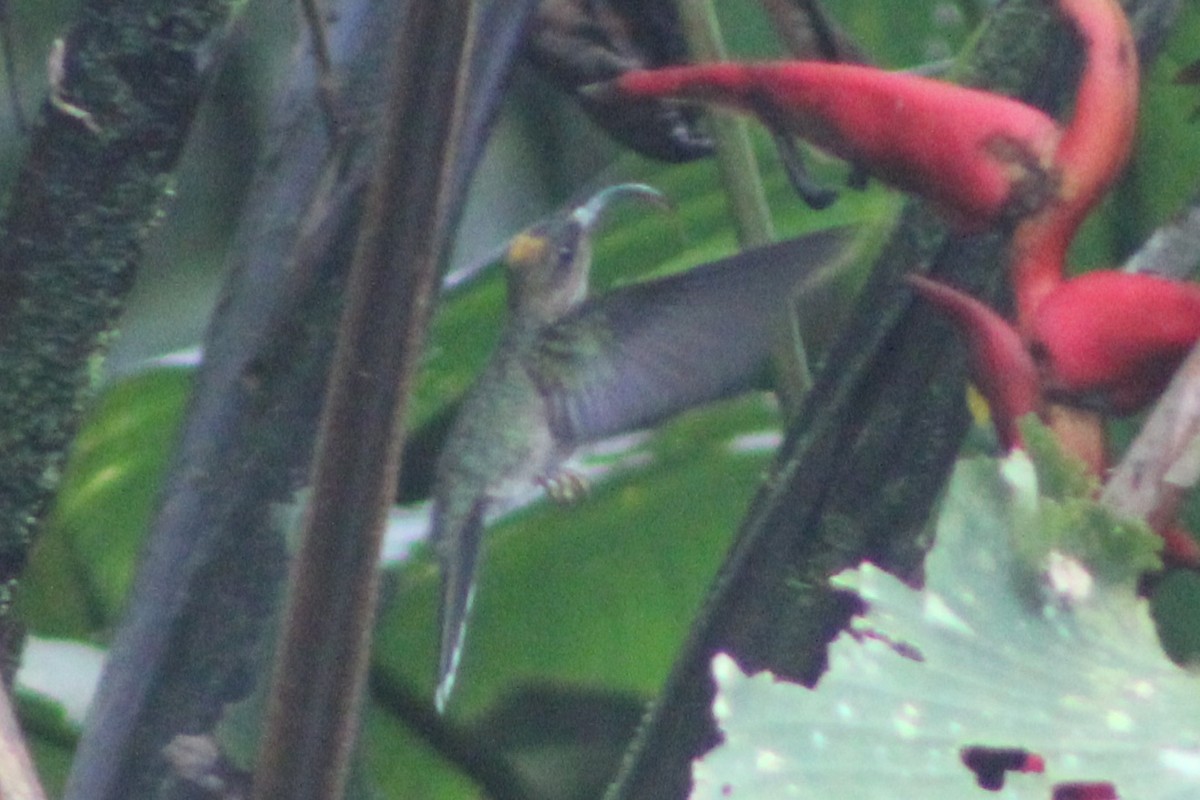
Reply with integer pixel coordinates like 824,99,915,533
432,494,487,711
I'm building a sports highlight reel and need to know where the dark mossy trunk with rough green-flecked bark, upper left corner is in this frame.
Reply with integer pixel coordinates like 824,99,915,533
0,0,238,609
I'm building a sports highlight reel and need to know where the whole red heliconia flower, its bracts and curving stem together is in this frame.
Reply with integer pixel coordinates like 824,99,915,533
613,0,1180,489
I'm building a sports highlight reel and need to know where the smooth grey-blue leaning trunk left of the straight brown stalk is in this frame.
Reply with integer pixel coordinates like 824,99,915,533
65,0,408,800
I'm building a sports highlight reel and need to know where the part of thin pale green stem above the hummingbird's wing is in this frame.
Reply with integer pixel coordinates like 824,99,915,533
677,0,775,247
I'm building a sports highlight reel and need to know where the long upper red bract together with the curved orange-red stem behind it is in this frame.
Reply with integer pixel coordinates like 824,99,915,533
612,0,1138,253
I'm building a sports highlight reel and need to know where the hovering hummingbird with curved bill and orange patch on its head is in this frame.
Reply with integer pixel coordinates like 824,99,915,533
430,184,851,711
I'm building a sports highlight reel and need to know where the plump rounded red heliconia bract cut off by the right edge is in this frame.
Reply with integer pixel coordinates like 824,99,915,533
1030,270,1200,414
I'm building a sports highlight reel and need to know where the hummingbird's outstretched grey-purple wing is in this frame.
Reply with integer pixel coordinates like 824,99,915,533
530,228,852,444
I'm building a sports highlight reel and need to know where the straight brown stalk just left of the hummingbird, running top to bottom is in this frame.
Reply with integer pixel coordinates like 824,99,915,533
253,0,470,800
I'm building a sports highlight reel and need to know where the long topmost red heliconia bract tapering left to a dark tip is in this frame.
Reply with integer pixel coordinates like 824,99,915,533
613,61,1061,231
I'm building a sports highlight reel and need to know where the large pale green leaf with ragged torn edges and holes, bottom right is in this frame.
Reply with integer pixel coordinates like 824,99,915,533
692,451,1200,800
